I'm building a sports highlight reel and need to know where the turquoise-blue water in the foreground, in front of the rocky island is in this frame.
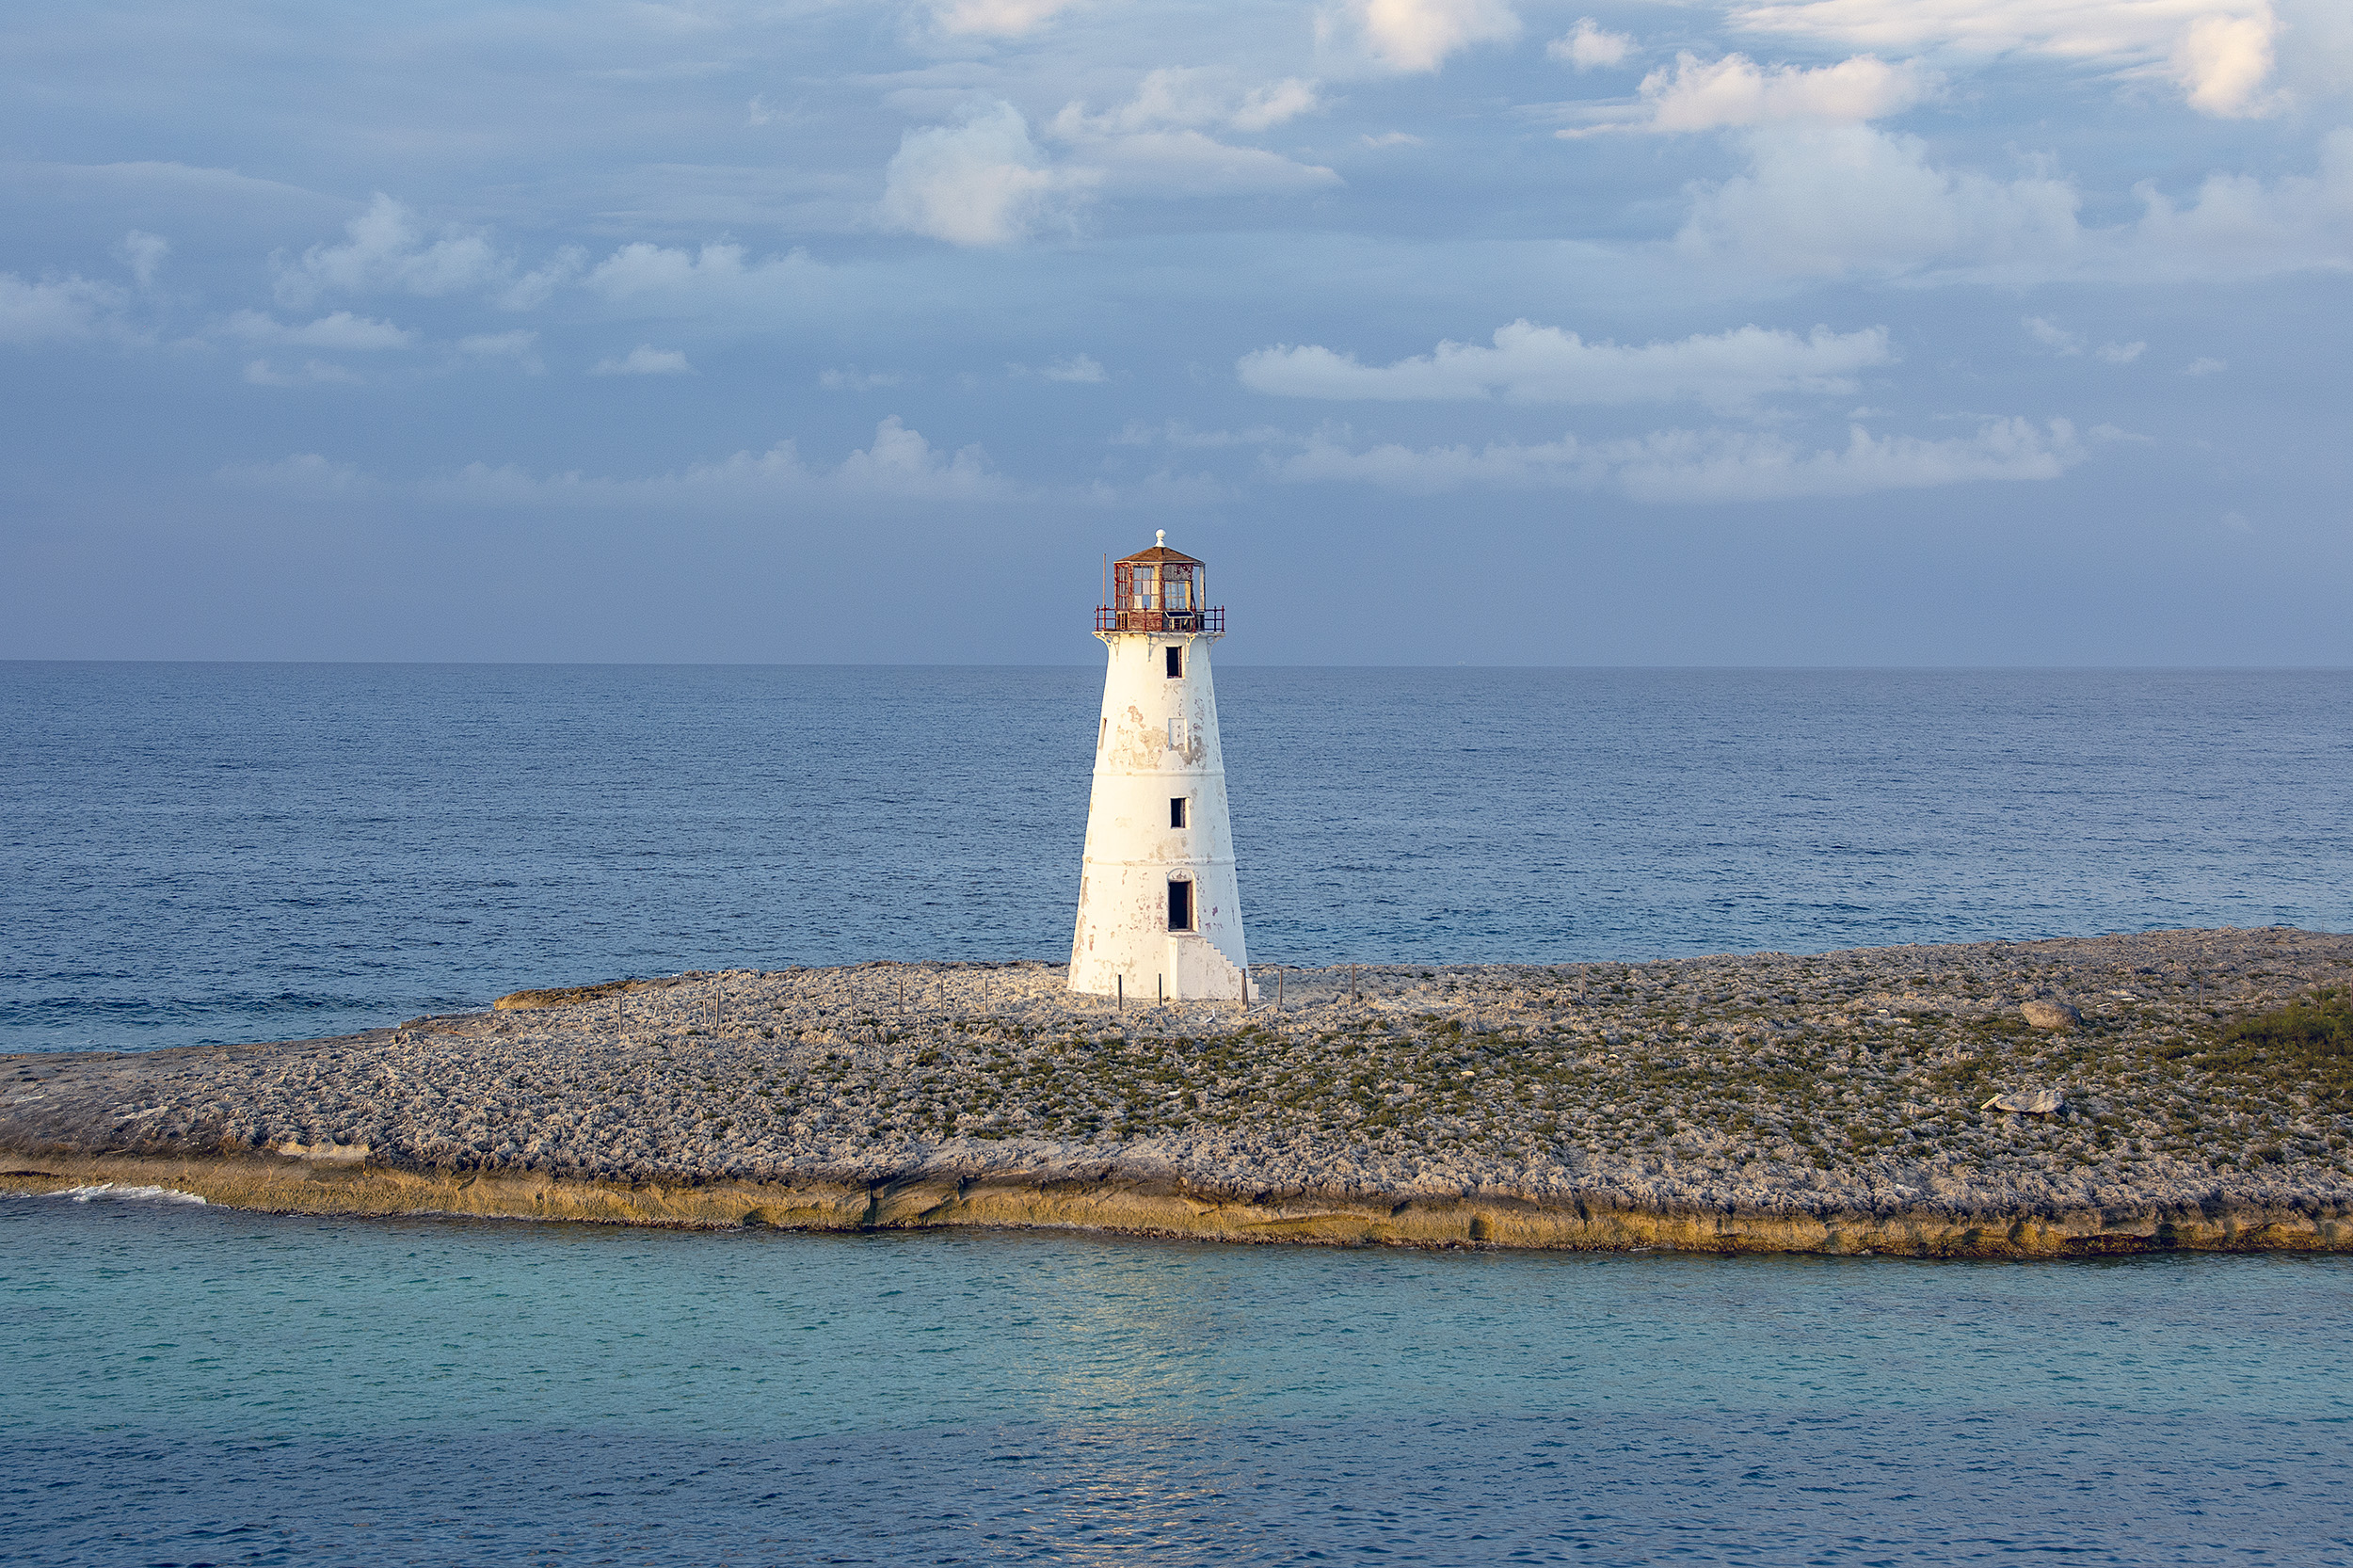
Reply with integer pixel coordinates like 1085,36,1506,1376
0,1198,2353,1563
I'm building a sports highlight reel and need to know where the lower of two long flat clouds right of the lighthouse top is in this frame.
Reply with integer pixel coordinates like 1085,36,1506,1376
1273,419,2085,504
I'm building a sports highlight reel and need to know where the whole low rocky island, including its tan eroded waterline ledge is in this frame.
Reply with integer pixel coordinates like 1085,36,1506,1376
0,928,2353,1257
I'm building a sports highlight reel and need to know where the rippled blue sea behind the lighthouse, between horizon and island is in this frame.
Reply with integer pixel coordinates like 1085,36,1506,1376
13,664,2353,1050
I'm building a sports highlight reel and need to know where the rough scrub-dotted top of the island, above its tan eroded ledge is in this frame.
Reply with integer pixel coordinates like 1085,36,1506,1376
18,933,2353,1206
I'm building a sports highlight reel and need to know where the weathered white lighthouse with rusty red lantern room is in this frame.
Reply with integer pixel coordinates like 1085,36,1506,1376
1071,530,1252,1000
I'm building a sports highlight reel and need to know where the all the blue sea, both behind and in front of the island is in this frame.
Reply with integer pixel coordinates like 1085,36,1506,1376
0,664,2353,1565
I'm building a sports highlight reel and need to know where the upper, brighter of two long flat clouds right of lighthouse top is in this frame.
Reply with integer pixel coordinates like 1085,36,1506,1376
1236,320,1895,408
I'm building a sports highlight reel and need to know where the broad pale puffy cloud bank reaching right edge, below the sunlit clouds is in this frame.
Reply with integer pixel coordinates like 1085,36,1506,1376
1678,125,2353,282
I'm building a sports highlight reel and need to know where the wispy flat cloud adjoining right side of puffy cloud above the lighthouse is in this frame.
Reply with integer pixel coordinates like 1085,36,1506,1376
1049,69,1341,196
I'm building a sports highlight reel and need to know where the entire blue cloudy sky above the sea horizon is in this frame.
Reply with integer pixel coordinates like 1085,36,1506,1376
0,0,2353,666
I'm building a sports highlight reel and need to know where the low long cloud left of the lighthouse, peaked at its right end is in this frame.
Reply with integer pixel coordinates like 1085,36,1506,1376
414,414,1016,511
